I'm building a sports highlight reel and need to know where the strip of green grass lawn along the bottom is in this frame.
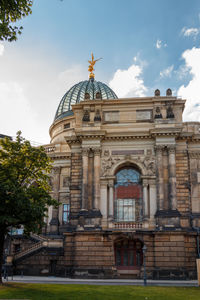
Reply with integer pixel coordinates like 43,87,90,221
0,283,200,300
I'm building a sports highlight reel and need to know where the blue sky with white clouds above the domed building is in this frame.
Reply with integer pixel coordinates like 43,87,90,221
0,0,200,144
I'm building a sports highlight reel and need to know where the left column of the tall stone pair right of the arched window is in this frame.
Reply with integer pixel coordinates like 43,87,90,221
156,146,164,210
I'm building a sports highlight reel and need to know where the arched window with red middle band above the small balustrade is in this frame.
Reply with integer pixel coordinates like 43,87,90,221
114,167,142,222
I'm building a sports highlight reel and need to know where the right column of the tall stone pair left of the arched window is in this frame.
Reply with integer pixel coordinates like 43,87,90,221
94,148,101,209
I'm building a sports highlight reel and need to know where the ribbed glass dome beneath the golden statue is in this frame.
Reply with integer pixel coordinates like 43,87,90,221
54,79,118,121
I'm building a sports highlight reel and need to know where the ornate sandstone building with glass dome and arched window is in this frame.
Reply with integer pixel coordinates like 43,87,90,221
8,60,200,278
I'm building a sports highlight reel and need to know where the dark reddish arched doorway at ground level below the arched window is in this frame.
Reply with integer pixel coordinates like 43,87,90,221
114,239,143,270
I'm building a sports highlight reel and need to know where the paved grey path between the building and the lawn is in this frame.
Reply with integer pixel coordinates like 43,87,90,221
4,276,198,287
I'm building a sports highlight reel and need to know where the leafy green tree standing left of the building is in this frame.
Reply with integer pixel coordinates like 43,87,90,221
0,132,57,283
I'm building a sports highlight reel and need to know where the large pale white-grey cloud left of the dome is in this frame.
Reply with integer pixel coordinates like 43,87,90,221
0,45,88,144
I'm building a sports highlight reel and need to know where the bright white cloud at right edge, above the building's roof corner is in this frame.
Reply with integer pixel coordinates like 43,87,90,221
177,47,200,121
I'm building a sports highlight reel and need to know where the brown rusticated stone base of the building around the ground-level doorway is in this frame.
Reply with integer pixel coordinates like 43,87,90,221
12,231,197,279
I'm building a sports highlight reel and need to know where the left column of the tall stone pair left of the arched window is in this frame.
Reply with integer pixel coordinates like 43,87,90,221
81,148,89,209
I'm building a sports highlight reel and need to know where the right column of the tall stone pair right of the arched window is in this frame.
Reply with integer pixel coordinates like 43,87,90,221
168,145,177,210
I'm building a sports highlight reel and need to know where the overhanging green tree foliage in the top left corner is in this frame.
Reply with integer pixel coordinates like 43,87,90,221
0,0,33,42
